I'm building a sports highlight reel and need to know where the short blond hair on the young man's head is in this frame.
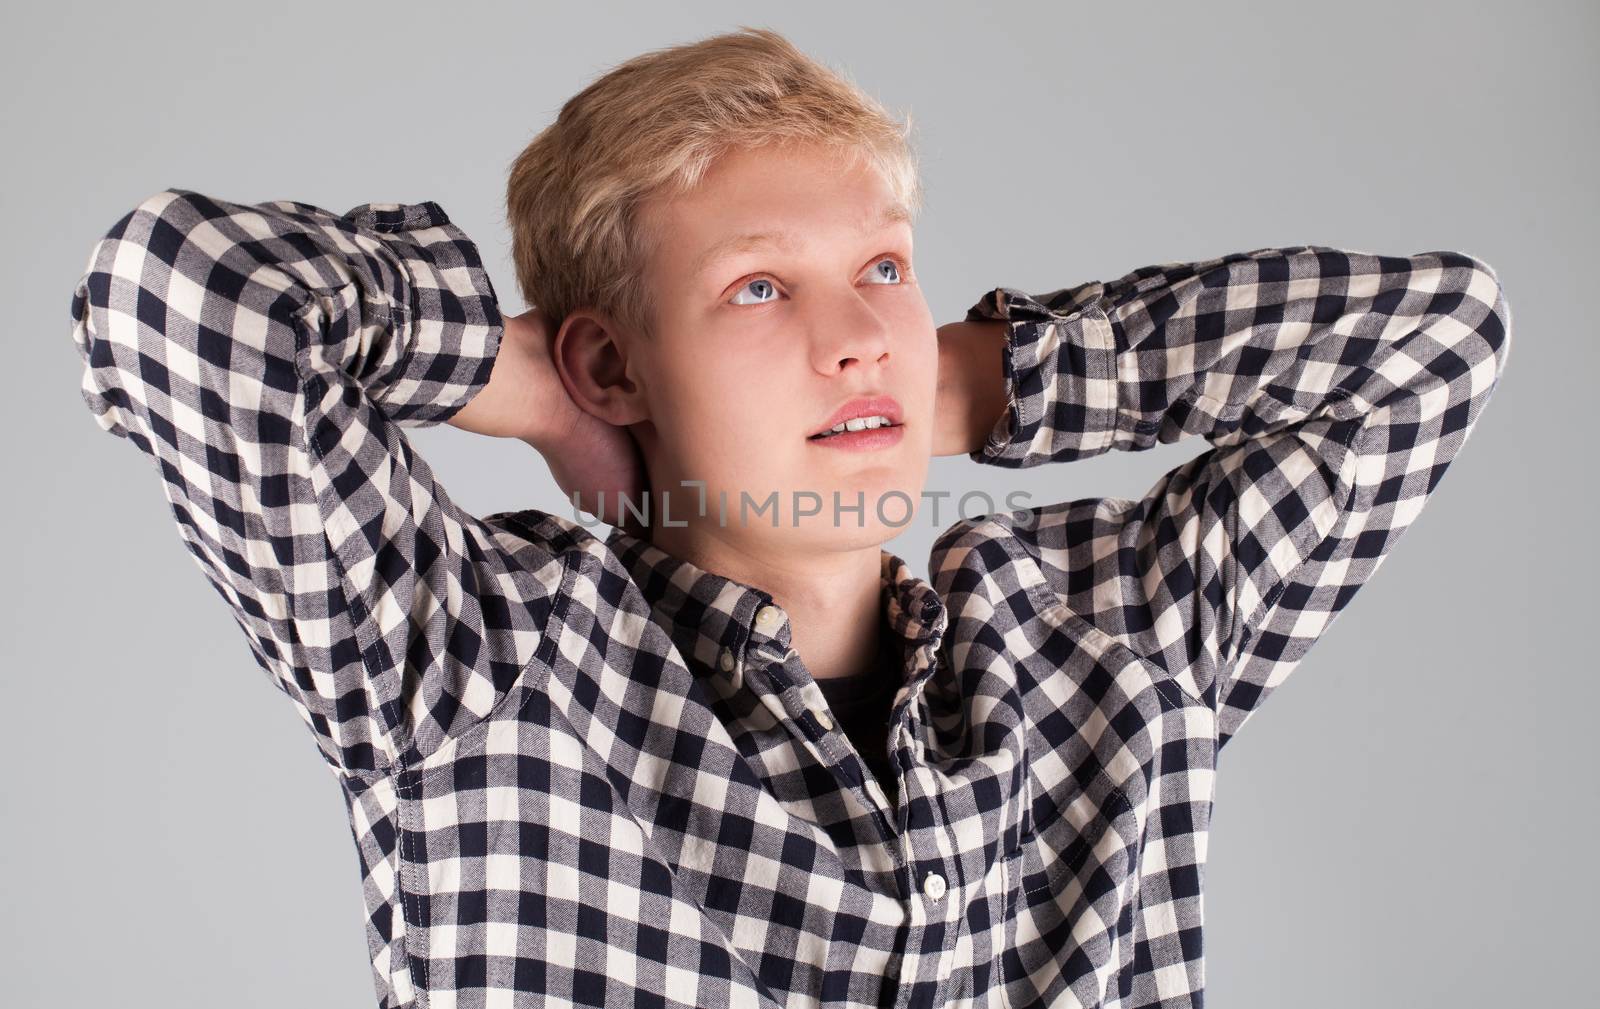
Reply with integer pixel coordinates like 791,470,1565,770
506,27,922,336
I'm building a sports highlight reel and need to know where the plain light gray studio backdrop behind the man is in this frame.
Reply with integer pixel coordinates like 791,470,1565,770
0,2,1600,1009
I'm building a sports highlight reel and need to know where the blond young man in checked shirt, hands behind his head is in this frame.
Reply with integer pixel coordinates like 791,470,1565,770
72,30,1509,1009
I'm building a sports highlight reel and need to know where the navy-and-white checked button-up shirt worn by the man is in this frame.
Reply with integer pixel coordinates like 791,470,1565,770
72,189,1510,1009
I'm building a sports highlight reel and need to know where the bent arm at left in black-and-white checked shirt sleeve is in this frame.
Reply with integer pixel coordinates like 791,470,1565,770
72,189,579,776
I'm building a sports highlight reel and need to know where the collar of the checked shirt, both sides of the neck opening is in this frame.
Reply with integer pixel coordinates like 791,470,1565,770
605,528,946,686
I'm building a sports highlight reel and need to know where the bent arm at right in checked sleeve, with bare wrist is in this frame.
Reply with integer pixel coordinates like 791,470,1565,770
941,246,1510,742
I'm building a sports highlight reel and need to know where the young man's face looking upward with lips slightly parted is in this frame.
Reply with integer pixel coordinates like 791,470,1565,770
629,144,938,550
